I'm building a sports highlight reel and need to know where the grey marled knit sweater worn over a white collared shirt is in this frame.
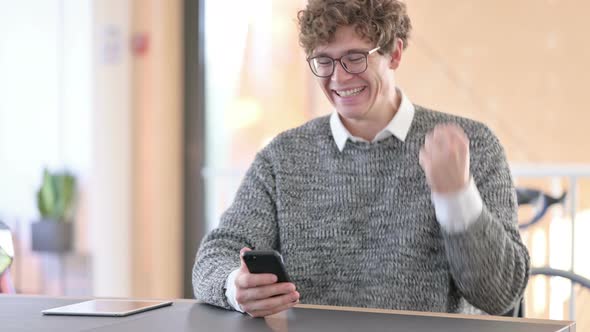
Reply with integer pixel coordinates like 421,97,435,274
192,106,529,314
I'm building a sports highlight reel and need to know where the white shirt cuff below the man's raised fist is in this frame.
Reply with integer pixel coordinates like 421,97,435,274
432,178,483,233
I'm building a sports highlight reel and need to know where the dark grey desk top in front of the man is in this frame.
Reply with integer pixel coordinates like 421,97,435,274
0,295,575,332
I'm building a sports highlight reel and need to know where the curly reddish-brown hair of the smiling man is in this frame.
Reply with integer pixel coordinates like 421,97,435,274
297,0,412,56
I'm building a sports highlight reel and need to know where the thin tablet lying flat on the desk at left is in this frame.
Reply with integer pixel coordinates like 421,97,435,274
41,300,172,317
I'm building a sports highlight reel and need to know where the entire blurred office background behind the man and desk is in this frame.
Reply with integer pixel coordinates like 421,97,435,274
0,0,590,330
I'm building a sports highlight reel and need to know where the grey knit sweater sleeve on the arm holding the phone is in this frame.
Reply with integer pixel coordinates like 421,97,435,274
192,152,278,309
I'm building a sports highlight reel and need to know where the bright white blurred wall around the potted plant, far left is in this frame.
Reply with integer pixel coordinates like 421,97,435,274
0,0,92,292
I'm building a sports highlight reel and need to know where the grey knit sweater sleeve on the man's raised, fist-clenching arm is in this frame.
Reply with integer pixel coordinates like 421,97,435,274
443,127,530,314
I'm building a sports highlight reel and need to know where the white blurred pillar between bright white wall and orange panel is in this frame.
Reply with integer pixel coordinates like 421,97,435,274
89,0,133,297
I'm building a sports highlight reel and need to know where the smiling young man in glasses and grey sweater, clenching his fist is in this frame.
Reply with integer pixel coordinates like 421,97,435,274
193,0,529,316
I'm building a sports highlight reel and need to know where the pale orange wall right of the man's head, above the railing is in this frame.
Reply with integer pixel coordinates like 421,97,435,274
398,0,590,163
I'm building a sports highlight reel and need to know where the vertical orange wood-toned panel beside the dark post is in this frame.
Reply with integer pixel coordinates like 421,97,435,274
131,0,183,298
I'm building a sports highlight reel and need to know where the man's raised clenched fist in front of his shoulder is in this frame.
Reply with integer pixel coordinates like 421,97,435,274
420,124,470,194
